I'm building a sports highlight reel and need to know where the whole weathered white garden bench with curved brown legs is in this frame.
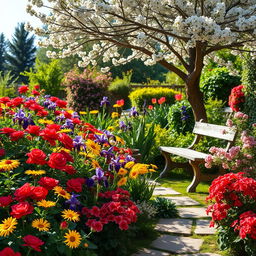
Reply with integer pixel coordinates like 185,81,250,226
159,121,236,192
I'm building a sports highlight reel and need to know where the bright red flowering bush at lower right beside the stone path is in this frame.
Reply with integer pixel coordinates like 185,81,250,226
207,172,256,256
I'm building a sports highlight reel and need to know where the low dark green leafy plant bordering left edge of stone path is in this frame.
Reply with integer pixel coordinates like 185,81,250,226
152,197,179,218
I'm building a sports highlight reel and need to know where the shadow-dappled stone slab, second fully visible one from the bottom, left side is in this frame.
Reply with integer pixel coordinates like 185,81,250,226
155,219,193,235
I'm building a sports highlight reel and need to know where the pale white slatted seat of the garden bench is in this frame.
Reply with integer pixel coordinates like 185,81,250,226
160,147,208,161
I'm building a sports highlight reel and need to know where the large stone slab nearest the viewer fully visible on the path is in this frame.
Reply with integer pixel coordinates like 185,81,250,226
151,235,203,253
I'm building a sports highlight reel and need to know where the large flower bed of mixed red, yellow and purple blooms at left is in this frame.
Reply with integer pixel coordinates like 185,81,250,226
0,86,154,255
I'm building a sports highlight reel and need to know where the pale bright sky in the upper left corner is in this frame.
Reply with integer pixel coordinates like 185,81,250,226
0,0,44,40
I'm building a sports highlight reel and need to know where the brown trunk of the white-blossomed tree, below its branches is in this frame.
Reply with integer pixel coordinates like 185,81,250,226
186,77,207,122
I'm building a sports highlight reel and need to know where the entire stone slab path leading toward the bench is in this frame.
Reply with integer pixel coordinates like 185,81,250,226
133,186,220,256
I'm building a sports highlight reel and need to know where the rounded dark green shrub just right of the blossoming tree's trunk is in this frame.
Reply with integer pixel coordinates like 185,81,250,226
200,67,241,102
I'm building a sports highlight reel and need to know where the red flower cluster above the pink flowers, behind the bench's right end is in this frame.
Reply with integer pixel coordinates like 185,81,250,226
228,85,245,112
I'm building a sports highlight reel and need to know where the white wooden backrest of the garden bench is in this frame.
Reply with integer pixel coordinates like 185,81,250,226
193,122,236,142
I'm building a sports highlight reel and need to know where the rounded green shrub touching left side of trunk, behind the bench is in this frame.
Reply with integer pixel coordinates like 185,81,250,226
167,100,195,134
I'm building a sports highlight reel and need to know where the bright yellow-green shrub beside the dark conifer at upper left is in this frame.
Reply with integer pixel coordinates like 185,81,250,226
22,59,64,96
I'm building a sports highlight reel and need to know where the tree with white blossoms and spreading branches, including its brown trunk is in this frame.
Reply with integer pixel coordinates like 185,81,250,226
27,0,256,120
